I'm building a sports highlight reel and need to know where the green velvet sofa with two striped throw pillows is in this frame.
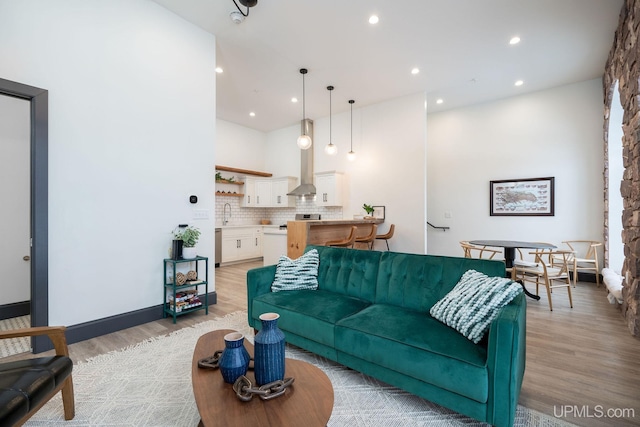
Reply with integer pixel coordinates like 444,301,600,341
247,246,526,426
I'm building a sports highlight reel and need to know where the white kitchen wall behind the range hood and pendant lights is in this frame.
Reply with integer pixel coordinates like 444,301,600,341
216,93,426,253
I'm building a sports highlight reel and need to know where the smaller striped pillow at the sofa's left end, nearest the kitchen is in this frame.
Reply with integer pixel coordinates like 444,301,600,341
271,249,320,292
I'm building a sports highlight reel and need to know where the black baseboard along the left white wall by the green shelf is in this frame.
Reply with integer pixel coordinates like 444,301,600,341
35,291,218,351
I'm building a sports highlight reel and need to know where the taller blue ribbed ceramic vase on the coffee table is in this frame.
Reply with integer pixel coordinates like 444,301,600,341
253,313,284,385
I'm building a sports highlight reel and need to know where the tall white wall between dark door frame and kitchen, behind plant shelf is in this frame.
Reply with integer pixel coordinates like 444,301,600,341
0,0,216,325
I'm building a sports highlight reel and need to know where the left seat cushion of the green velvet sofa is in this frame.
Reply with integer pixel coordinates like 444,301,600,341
252,289,370,347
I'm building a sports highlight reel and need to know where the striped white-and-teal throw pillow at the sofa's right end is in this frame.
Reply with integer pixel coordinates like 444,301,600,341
429,270,522,344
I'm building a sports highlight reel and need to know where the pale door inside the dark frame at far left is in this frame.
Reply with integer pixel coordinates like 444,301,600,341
0,95,31,318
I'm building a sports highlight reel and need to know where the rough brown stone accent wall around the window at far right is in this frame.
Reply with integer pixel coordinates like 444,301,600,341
603,0,640,337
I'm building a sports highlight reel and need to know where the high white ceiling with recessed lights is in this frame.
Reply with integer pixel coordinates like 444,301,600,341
154,0,623,132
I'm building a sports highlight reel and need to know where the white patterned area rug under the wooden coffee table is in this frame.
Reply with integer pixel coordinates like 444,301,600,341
26,312,569,427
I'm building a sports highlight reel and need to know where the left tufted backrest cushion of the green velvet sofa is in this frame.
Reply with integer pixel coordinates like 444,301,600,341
306,246,381,302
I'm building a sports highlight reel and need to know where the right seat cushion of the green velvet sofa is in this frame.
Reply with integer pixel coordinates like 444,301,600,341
336,304,489,403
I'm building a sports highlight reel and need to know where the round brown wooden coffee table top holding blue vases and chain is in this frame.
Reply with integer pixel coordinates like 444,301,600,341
191,329,333,427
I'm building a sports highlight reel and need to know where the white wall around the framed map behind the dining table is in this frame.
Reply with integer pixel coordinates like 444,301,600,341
427,79,604,256
